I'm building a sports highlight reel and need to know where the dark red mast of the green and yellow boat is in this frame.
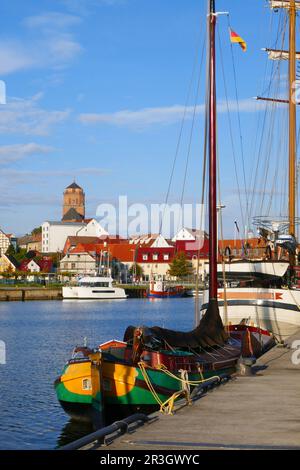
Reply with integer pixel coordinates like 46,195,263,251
209,0,218,302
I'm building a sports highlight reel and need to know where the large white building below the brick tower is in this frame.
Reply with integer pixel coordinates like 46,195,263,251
42,219,108,253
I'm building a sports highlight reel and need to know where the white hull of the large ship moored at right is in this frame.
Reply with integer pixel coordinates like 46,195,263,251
201,288,300,339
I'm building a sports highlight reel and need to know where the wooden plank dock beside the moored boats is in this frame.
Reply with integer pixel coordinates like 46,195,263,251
97,330,300,451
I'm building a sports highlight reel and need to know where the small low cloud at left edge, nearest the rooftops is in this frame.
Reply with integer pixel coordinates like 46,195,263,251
0,142,54,165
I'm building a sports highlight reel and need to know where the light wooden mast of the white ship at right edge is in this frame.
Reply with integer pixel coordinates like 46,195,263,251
289,0,296,236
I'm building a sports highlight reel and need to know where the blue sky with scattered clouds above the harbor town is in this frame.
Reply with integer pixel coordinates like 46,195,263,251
0,0,296,236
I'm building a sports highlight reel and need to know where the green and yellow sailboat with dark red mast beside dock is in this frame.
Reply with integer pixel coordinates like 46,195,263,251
55,0,273,417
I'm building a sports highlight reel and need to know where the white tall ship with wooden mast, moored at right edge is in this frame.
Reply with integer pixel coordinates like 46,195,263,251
201,0,300,340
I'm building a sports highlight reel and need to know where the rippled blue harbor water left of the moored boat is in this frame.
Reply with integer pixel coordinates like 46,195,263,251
0,298,194,450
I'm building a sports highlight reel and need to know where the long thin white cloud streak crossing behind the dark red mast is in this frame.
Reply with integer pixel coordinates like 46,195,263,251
79,99,262,128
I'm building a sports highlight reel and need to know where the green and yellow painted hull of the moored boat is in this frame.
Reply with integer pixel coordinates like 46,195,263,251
55,346,239,419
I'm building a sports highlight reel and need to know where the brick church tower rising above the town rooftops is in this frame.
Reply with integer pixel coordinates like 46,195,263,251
62,181,85,222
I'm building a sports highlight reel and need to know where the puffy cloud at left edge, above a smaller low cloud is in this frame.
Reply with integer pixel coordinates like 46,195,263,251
0,94,70,136
